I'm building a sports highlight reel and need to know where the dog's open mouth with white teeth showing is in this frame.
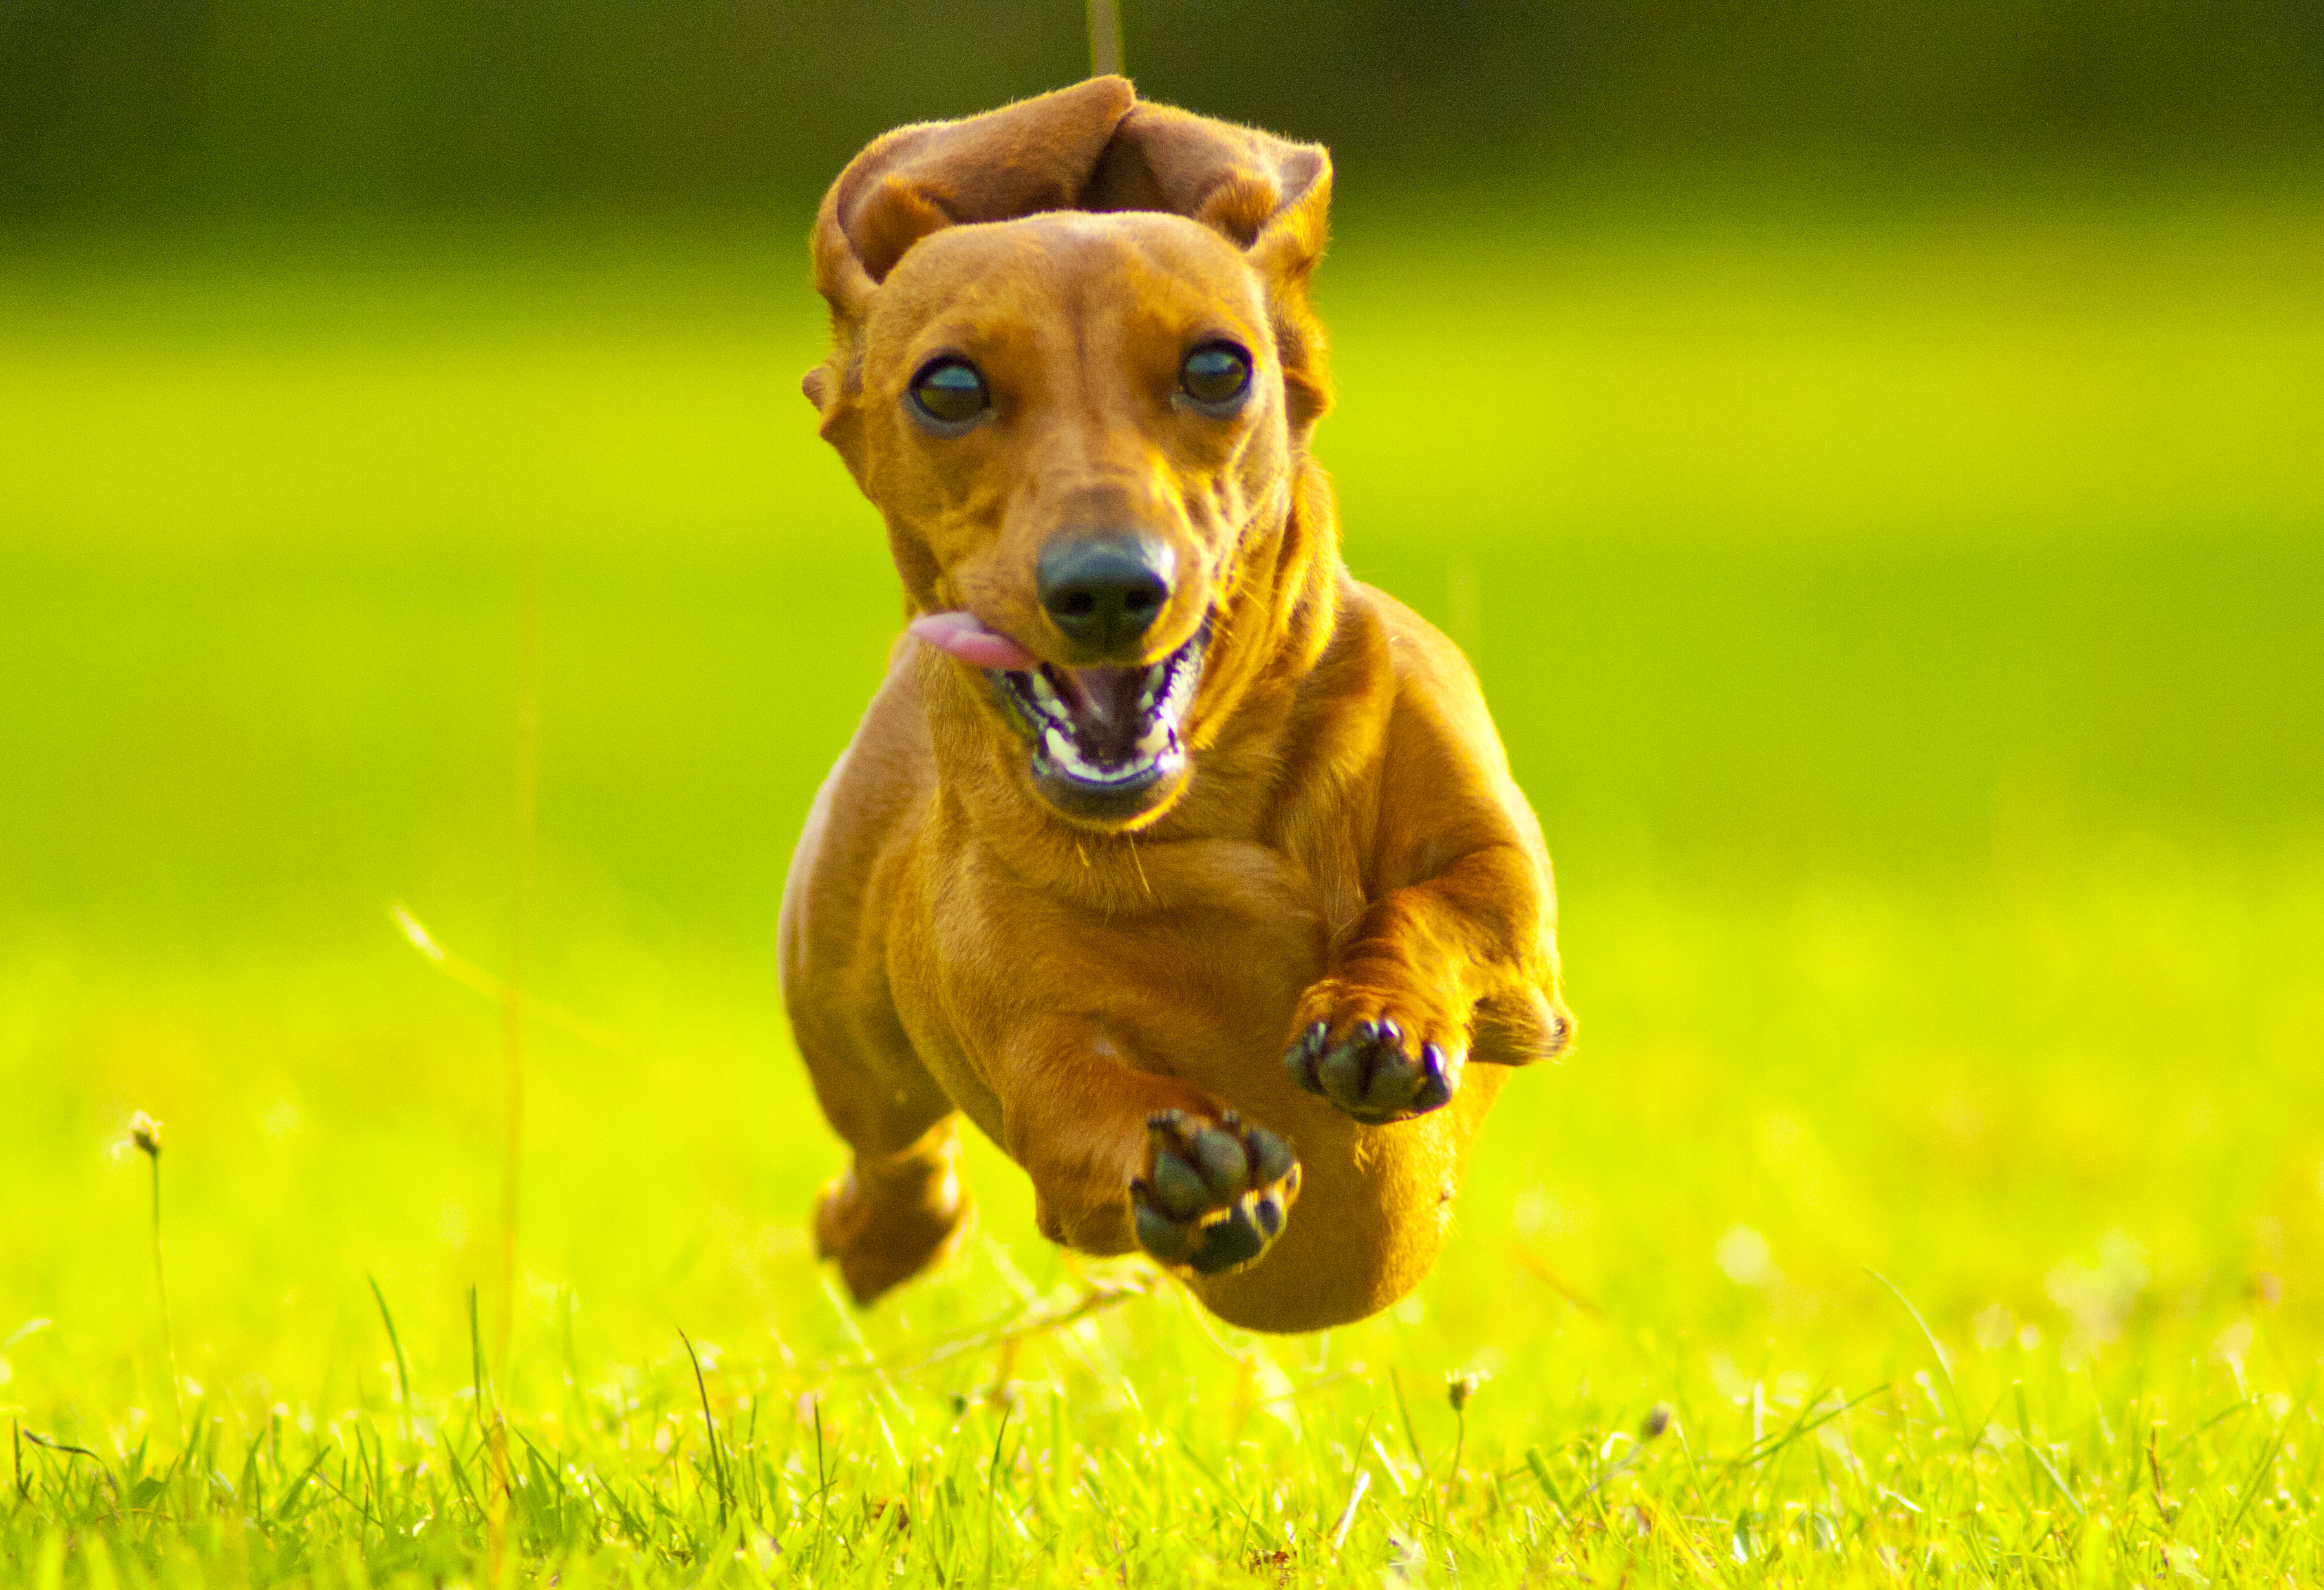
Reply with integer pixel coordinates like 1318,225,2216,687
985,625,1210,806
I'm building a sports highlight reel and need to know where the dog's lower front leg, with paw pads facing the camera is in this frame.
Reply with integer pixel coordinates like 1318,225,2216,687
995,1018,1299,1276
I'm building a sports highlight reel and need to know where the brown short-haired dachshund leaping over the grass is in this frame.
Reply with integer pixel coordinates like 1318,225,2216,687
781,77,1569,1329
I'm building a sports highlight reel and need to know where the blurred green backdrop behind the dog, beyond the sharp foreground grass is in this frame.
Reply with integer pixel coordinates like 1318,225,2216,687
0,0,2324,1469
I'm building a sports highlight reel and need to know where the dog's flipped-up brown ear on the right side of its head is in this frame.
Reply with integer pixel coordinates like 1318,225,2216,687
1081,105,1331,437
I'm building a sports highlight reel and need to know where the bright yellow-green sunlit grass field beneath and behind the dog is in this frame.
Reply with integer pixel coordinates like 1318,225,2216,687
0,200,2324,1590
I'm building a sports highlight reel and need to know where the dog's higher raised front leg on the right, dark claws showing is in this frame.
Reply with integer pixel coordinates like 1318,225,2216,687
1283,841,1571,1125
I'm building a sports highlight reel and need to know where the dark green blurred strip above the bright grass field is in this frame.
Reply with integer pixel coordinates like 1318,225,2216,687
14,0,2324,226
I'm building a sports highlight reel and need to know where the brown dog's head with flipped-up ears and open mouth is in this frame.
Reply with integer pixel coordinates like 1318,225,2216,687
806,77,1331,828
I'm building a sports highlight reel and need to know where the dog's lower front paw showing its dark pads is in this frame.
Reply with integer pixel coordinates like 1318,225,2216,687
1130,1109,1299,1276
